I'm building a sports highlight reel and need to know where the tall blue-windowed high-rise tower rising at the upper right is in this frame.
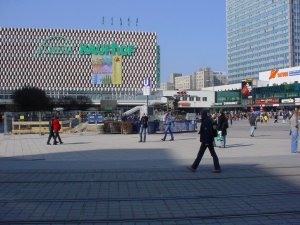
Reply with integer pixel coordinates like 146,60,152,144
226,0,300,83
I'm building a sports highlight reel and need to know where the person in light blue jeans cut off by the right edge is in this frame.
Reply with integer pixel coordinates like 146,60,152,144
289,108,299,153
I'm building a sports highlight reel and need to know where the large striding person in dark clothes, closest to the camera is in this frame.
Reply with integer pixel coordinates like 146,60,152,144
187,111,221,173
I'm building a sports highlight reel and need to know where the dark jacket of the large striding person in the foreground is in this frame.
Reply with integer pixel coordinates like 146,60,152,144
199,111,214,144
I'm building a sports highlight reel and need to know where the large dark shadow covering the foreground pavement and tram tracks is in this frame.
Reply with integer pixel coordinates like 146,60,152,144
0,148,300,225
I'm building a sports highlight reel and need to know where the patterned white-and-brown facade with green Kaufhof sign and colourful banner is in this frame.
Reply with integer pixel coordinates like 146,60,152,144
0,28,160,102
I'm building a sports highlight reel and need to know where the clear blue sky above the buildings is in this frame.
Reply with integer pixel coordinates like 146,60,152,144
0,0,227,82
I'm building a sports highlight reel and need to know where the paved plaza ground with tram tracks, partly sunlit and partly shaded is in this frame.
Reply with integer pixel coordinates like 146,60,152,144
0,120,300,225
